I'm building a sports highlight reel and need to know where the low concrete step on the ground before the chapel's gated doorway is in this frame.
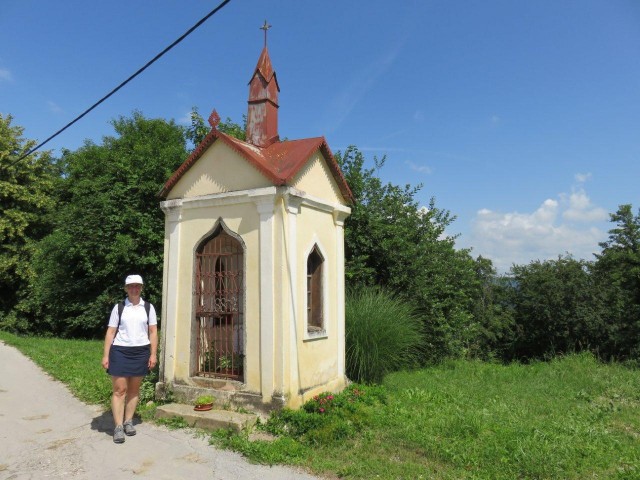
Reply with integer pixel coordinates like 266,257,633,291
156,403,258,432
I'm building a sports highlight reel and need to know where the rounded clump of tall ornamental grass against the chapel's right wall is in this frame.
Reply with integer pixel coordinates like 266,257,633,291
345,287,424,383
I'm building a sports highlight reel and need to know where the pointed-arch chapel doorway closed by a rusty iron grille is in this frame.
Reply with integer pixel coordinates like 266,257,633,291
194,221,244,382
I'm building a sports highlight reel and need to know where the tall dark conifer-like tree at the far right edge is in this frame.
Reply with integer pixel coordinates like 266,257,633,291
595,204,640,359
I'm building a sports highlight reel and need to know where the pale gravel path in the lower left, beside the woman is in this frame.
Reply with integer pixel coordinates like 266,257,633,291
0,342,316,480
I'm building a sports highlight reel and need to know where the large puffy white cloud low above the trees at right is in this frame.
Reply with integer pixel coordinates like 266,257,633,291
465,185,607,273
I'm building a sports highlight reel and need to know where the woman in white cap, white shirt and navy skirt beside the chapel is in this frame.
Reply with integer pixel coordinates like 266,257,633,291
102,275,158,443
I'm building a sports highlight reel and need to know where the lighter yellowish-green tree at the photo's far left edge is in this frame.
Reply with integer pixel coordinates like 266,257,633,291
0,114,60,328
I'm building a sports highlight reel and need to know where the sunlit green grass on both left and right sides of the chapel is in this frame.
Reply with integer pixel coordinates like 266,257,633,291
0,332,640,480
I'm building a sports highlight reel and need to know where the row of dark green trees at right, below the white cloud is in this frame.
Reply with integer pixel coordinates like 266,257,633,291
476,205,640,361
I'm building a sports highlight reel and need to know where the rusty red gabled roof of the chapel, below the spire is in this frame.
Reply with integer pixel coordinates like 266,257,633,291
159,129,353,203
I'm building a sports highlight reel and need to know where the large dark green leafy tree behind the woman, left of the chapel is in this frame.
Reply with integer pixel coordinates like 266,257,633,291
18,112,187,337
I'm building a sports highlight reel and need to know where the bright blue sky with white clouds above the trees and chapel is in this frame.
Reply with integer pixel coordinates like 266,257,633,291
0,0,640,271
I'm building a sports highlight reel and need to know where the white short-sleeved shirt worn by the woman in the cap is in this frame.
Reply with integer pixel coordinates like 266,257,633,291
109,298,158,347
